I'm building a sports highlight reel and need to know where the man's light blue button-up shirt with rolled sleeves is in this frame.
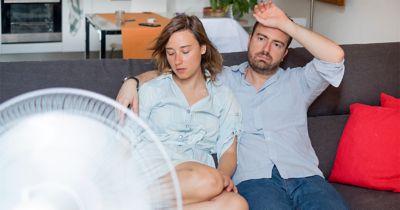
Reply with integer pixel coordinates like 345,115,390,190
219,59,344,184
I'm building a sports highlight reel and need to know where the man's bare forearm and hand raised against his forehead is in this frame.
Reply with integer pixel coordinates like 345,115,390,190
254,0,344,63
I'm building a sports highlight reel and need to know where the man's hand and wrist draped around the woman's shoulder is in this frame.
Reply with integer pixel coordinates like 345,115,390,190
116,70,158,113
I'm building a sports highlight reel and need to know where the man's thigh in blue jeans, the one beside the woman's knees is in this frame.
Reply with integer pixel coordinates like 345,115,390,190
237,179,292,210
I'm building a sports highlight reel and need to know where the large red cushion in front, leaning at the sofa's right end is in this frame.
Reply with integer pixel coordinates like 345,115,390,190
329,104,400,192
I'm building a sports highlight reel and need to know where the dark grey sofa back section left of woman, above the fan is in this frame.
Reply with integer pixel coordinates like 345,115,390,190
0,59,154,103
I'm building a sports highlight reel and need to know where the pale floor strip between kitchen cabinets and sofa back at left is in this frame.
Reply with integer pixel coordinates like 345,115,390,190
0,51,122,62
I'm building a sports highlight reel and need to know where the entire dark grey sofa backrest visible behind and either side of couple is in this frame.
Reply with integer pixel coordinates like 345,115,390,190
0,42,400,116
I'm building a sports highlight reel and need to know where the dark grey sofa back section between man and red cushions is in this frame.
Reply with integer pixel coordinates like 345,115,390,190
308,42,400,116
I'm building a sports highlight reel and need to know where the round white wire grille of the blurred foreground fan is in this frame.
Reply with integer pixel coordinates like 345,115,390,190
0,88,181,210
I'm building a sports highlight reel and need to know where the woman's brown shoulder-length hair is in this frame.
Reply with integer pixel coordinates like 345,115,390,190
152,15,222,81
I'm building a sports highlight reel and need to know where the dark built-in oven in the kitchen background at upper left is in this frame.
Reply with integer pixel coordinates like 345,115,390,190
1,0,62,44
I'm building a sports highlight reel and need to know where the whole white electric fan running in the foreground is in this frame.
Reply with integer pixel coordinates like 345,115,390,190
0,88,182,210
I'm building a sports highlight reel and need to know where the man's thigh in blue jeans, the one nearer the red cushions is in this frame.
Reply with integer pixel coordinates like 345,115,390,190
288,176,349,210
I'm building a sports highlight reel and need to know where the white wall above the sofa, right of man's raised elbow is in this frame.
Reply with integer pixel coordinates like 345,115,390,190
314,0,400,44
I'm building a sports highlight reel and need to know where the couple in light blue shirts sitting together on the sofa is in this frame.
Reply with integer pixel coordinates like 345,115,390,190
117,1,348,210
